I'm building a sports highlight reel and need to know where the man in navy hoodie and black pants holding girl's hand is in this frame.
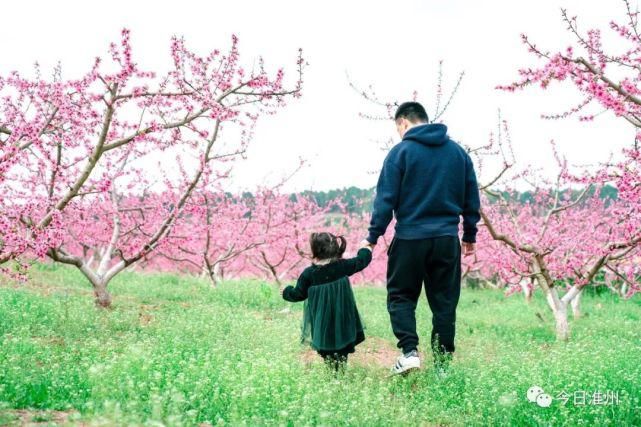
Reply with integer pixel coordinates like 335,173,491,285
366,102,480,374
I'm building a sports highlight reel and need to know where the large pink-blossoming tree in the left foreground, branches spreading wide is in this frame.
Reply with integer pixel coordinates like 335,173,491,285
0,29,305,306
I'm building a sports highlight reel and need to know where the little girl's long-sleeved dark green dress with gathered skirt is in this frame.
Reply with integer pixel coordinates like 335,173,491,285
283,248,372,354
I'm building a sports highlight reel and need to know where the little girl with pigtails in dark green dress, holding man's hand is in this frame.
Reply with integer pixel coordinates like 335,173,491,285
281,233,372,371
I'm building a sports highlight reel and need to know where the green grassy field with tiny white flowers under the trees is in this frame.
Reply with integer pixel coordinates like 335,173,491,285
0,265,641,426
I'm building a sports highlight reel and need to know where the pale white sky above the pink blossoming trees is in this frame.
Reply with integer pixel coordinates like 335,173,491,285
0,0,634,190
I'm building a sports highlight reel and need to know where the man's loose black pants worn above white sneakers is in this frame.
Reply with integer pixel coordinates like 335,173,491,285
387,236,461,357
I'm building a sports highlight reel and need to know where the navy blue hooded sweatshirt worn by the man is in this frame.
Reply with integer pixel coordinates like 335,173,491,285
367,124,480,243
